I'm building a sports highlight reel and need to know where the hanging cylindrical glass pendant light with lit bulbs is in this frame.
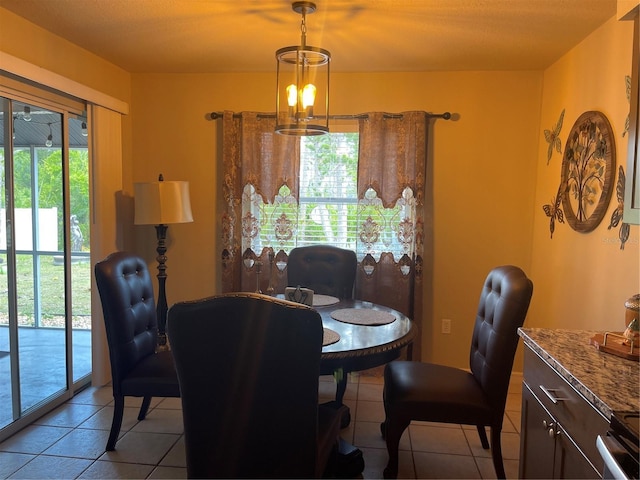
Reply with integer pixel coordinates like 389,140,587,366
276,2,331,136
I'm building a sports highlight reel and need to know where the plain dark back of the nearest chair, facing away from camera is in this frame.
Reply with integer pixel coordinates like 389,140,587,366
168,293,323,478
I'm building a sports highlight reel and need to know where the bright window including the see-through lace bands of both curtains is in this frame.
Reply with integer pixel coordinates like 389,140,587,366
242,132,415,260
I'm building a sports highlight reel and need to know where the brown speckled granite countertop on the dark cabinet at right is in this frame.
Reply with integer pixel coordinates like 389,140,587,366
518,328,640,419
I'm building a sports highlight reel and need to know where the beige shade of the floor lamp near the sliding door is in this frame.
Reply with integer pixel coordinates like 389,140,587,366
133,181,193,225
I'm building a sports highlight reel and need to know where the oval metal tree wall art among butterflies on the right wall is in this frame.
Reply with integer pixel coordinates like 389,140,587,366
560,112,615,232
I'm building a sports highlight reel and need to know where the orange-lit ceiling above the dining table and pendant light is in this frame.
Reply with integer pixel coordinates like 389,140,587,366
0,0,616,73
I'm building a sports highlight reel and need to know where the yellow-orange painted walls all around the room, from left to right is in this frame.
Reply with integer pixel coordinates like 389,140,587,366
0,8,640,371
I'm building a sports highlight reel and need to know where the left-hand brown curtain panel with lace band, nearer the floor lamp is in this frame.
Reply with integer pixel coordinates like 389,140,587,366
222,111,300,293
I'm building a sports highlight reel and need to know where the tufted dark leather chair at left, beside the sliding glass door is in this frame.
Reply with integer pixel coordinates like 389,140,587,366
94,252,180,450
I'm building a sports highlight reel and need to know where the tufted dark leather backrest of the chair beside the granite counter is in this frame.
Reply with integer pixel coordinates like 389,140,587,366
470,265,533,418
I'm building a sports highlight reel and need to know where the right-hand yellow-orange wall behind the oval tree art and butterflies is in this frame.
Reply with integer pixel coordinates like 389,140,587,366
530,18,640,341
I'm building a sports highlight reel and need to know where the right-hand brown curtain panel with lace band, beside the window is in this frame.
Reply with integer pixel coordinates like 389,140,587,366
355,111,427,359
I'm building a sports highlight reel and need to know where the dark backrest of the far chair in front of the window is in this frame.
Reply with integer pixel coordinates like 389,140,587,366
287,245,358,298
